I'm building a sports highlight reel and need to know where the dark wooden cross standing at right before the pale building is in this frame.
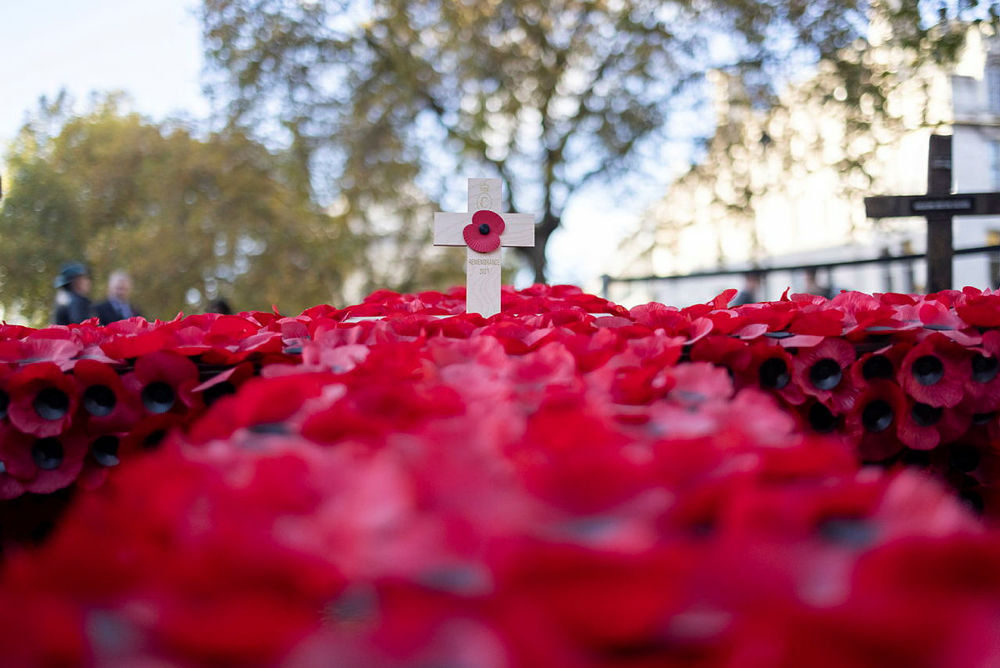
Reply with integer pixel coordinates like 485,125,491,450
865,135,1000,292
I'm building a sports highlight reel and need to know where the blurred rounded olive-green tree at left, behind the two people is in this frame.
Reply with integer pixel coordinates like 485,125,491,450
0,96,355,324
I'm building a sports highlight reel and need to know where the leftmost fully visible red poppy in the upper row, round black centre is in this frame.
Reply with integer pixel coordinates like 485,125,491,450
7,362,79,437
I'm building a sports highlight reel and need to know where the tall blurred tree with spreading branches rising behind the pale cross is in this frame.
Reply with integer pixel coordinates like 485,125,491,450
202,0,995,281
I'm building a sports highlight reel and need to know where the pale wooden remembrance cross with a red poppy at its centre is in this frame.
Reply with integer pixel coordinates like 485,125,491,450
434,179,535,318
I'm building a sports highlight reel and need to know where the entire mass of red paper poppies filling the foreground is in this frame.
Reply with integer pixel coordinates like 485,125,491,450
0,286,1000,667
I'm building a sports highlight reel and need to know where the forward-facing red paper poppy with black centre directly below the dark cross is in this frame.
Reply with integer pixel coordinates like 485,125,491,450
896,332,973,407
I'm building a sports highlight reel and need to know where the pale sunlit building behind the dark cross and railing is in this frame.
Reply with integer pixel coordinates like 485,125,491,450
610,28,1000,305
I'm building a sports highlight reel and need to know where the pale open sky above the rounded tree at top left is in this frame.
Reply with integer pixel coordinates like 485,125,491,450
0,0,209,144
